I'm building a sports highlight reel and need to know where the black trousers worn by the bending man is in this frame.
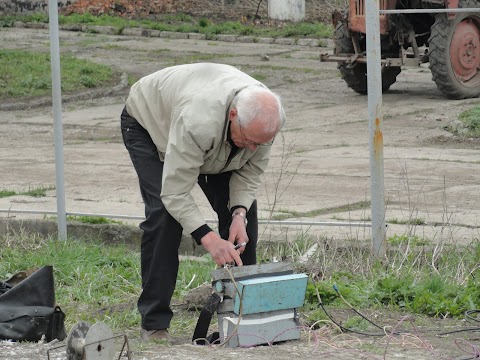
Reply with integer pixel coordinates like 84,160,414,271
121,109,258,330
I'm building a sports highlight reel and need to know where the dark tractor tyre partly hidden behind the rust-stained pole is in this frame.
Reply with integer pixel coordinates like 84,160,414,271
335,22,401,95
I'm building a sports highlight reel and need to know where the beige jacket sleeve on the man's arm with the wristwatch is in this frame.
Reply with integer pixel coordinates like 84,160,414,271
230,146,271,210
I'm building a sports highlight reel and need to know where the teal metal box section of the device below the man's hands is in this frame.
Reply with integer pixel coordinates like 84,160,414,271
233,274,308,315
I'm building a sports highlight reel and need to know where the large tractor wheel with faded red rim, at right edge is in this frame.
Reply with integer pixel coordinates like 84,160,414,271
428,0,480,99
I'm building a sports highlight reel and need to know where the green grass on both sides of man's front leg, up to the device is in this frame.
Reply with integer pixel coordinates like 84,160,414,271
0,234,214,331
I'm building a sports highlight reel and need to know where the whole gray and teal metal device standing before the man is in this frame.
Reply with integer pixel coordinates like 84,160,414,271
212,263,308,347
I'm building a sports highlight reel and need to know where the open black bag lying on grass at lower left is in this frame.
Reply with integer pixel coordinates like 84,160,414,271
0,266,66,342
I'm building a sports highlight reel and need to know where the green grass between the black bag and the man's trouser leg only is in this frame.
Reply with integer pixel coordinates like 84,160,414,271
0,236,140,328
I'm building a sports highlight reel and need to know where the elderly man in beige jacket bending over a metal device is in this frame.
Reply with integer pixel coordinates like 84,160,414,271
121,63,285,341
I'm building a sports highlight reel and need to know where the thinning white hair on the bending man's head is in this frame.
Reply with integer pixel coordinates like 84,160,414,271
233,85,285,132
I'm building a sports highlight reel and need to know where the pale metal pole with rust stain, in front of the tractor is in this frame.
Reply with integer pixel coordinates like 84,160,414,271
365,0,386,258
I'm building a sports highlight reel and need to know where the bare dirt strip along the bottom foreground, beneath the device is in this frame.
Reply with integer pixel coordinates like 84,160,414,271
0,312,480,360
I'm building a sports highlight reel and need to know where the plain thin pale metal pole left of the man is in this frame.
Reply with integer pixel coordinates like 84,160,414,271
48,0,67,240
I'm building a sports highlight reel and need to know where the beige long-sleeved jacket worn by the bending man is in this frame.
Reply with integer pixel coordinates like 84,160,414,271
126,63,276,233
